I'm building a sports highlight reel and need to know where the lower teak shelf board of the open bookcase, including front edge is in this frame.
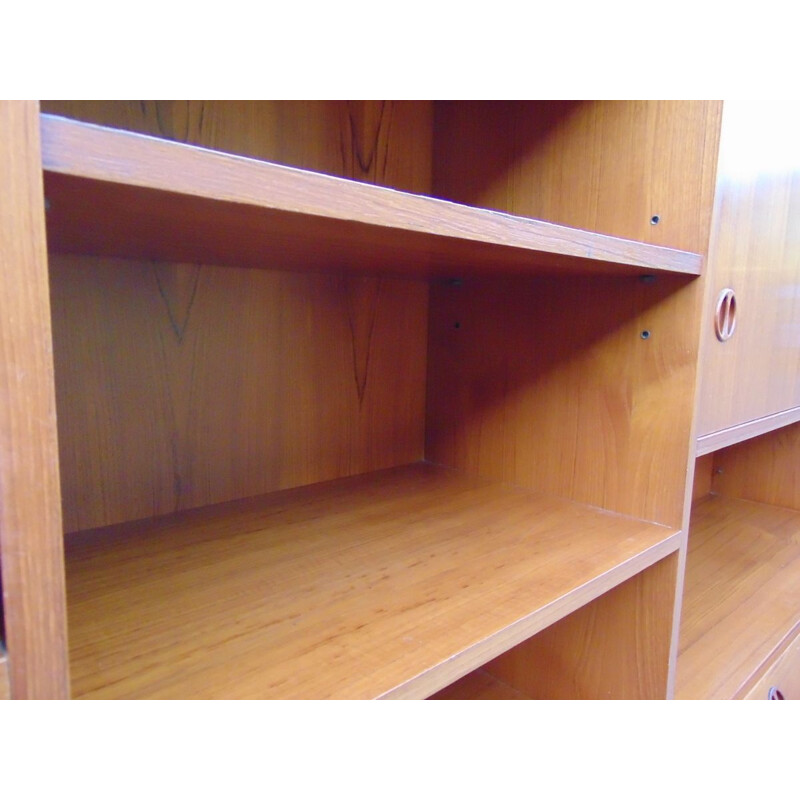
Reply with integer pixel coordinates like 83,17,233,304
66,463,680,698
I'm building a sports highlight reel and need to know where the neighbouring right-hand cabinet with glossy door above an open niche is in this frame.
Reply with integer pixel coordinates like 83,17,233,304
677,101,800,699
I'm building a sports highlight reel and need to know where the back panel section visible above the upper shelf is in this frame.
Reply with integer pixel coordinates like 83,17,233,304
42,100,433,194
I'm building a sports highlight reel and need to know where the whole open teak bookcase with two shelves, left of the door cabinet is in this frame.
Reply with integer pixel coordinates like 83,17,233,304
0,101,732,698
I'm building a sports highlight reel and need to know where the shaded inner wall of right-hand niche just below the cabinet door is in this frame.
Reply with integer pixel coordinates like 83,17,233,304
714,423,800,510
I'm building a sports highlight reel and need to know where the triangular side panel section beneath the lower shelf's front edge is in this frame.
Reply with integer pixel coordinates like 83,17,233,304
485,554,678,700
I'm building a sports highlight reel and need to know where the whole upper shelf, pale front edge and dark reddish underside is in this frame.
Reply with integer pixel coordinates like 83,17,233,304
41,114,702,277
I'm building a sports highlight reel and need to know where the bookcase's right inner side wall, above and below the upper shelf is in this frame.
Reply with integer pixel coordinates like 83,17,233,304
427,101,721,528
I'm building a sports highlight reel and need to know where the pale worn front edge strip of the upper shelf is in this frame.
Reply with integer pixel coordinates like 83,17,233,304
41,114,703,276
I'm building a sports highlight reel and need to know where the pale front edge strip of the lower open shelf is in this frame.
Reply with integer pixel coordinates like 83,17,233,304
378,531,681,700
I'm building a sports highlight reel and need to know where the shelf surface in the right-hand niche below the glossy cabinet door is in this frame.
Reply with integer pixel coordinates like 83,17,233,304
676,495,800,699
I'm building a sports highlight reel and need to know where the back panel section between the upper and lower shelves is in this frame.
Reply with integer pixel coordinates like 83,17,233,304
50,255,428,531
